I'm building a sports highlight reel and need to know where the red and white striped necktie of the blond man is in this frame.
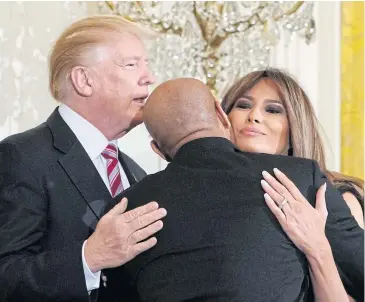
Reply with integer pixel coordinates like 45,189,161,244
101,144,124,197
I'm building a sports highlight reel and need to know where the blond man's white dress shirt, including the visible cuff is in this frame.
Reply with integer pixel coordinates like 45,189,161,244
58,104,130,291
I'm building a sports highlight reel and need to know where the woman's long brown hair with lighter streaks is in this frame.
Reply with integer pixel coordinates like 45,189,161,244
222,68,364,206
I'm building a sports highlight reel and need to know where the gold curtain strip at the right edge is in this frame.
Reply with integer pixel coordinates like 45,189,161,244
341,2,364,179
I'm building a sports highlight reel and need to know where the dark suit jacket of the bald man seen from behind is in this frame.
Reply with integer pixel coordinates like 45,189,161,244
111,138,364,302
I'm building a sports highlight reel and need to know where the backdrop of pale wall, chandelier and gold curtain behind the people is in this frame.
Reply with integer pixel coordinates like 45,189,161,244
0,1,364,179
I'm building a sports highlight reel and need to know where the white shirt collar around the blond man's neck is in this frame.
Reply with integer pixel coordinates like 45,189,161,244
58,103,118,160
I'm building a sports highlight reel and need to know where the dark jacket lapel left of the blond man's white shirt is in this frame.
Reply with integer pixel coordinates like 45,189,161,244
47,108,112,219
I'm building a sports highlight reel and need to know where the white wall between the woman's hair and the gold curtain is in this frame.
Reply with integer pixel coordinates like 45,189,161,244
271,1,341,170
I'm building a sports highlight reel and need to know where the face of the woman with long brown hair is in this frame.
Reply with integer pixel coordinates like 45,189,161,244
228,79,290,155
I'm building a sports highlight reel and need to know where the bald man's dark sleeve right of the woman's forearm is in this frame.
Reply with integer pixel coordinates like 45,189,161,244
314,163,364,301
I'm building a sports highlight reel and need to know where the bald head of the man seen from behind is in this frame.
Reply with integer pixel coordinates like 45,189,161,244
143,78,218,154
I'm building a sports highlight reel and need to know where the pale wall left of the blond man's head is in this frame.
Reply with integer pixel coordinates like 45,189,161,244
0,1,85,140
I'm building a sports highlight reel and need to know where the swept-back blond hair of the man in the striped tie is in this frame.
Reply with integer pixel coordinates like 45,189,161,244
49,15,153,101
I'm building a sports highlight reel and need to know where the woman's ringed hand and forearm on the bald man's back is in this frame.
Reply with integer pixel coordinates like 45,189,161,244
262,169,349,302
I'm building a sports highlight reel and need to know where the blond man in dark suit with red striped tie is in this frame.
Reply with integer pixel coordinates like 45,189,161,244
0,16,166,302
